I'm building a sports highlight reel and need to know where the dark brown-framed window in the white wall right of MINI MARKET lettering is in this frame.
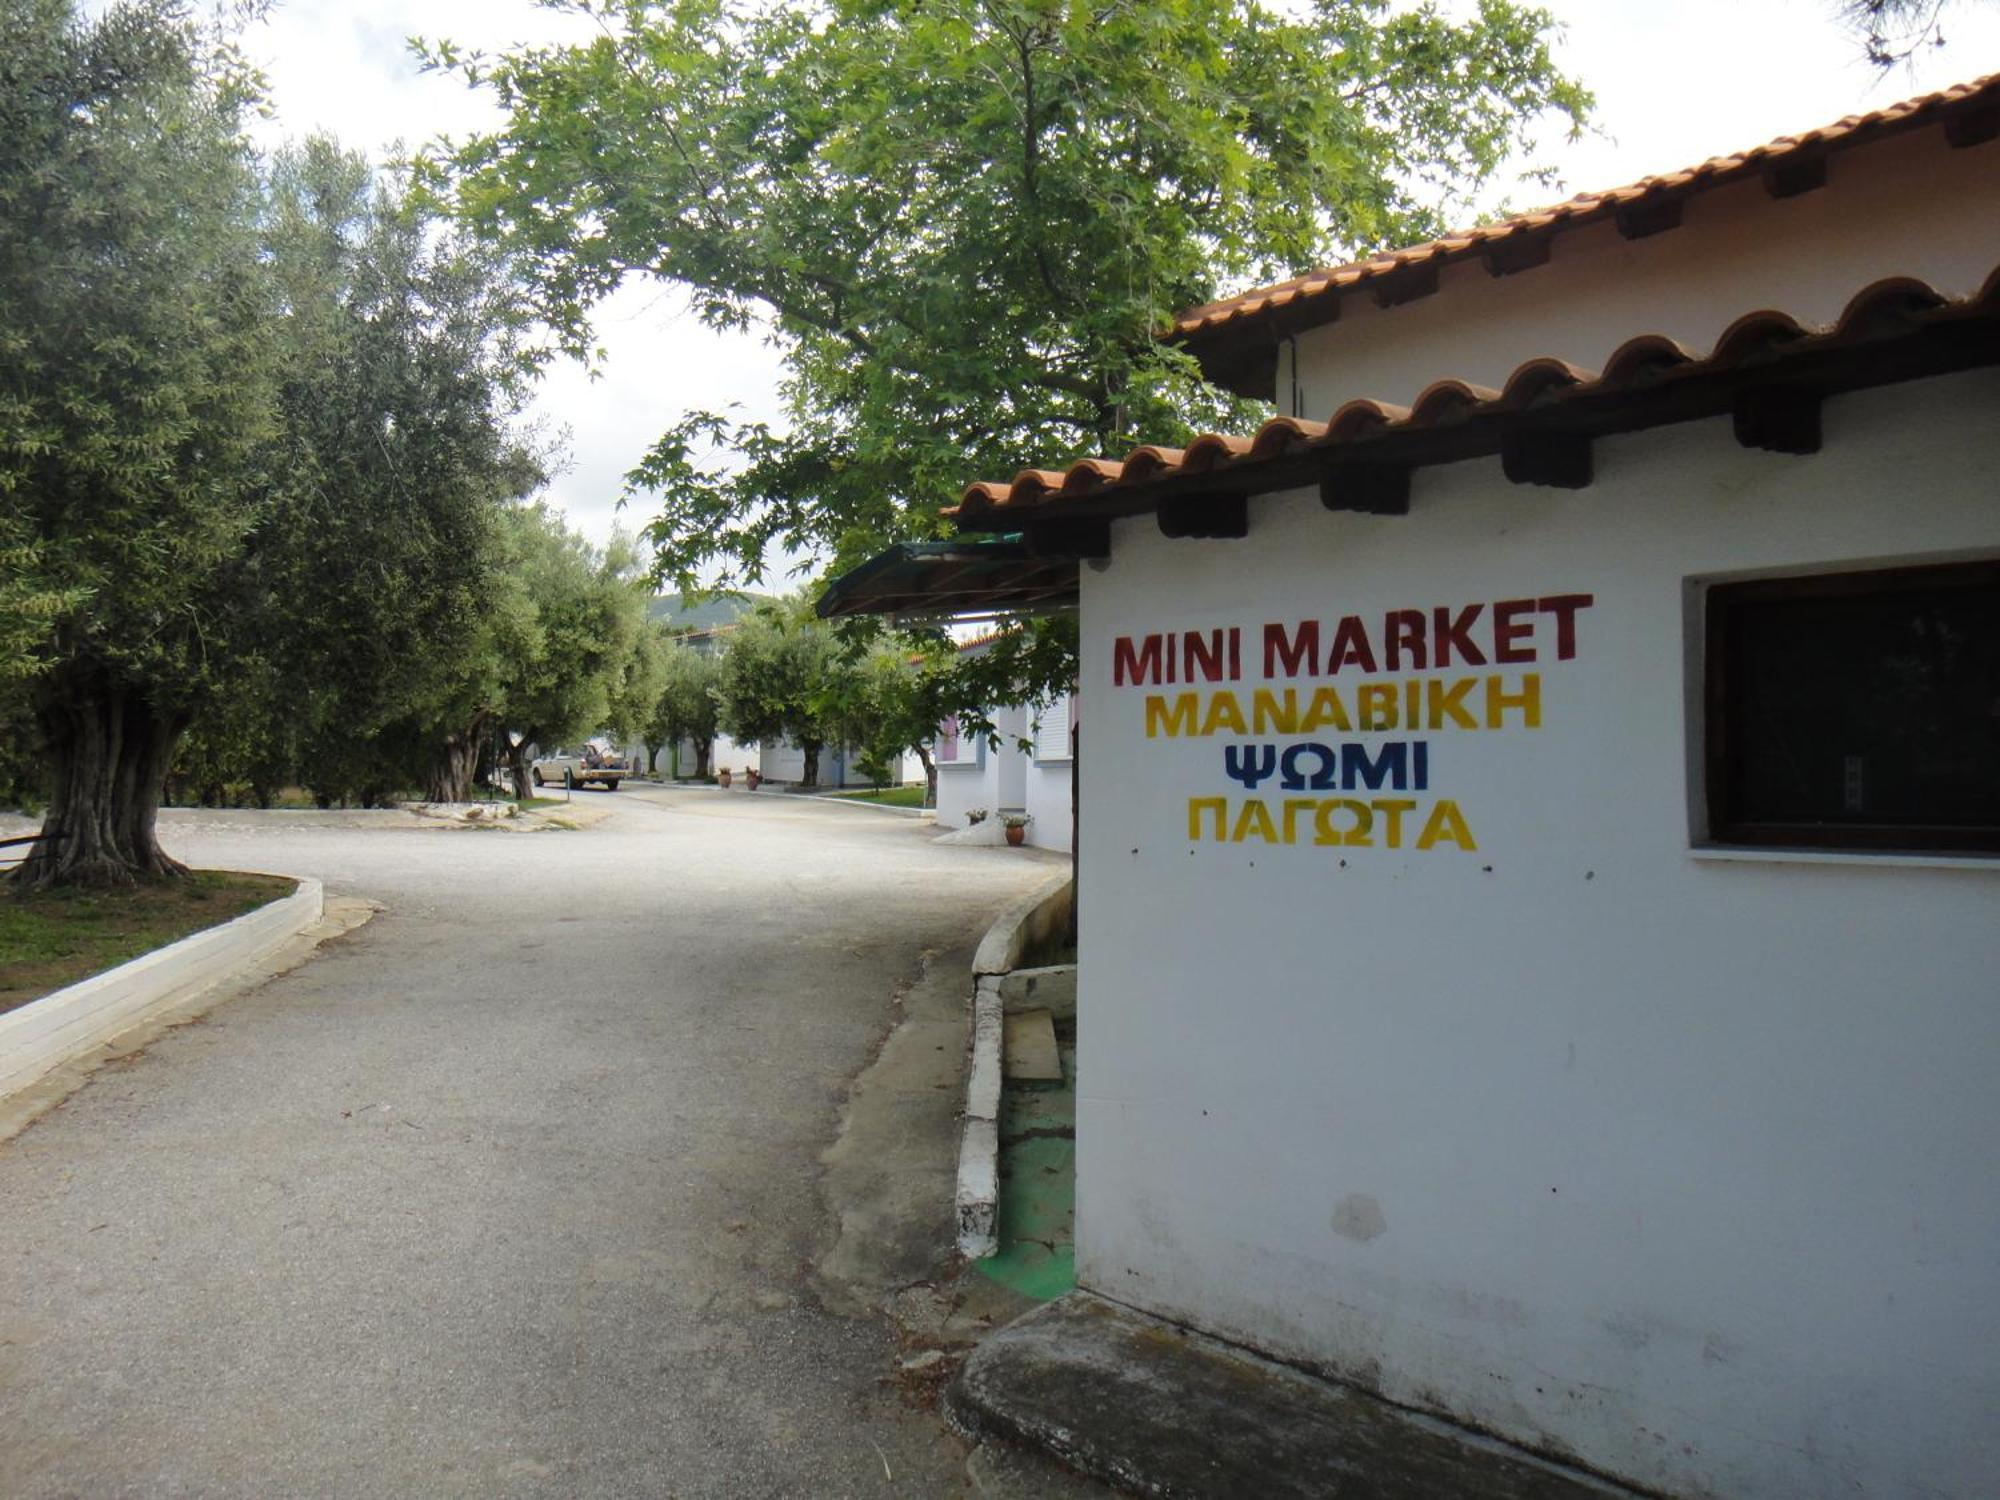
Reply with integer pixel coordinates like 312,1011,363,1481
1706,562,2000,854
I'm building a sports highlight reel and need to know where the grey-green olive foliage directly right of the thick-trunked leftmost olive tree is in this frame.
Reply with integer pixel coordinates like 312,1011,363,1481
242,138,542,812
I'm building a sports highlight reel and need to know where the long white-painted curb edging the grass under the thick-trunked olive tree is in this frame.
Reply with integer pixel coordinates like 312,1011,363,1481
0,876,326,1098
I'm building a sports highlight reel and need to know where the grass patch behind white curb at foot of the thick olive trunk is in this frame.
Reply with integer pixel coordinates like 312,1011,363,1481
0,870,298,1012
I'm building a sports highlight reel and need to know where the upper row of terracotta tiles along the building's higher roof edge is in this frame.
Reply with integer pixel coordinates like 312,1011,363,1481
1168,74,2000,350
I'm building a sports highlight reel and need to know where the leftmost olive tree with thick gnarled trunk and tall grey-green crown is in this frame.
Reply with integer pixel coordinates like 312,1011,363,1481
0,0,276,882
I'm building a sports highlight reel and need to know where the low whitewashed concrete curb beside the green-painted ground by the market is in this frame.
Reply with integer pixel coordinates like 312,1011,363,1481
952,874,1072,1260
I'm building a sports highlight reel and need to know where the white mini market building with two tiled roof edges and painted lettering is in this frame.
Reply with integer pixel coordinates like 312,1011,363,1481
824,80,2000,1500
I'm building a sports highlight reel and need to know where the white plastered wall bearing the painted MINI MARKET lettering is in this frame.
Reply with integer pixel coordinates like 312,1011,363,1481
1076,374,2000,1500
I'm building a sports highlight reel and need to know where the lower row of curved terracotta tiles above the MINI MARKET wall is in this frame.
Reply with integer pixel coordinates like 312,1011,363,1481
944,268,2000,530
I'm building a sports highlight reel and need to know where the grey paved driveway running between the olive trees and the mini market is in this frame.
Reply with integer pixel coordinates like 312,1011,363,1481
0,788,1050,1500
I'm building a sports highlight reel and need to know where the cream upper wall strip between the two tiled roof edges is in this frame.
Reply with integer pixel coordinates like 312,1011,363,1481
1278,126,2000,420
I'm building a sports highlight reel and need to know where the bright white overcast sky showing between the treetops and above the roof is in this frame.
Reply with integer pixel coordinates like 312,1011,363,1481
227,0,2000,564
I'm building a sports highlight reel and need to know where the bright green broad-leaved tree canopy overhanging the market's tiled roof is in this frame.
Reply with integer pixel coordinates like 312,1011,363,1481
428,0,1588,596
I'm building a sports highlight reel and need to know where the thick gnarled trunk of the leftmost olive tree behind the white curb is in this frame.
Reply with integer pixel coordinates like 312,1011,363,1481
14,662,188,888
